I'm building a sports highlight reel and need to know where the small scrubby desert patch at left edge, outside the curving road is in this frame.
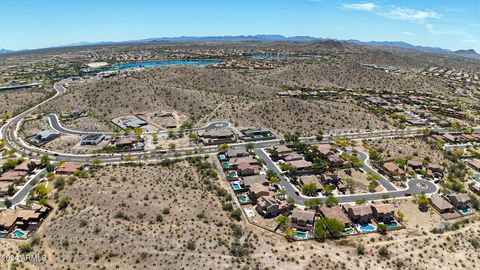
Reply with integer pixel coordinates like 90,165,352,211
0,90,47,115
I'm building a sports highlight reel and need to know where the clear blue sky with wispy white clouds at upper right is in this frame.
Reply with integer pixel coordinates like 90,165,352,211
0,0,480,52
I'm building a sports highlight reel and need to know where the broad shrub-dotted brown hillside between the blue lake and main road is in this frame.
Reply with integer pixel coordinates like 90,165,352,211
43,65,392,135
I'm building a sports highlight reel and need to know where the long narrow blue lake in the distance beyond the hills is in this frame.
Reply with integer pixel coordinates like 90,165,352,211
83,60,223,73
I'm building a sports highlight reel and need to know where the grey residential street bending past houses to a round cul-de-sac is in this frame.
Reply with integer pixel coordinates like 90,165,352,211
254,148,438,205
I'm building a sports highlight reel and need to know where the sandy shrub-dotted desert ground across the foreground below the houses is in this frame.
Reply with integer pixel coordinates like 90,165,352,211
0,159,480,269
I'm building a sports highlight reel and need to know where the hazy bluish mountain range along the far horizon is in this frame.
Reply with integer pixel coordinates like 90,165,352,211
0,35,480,59
